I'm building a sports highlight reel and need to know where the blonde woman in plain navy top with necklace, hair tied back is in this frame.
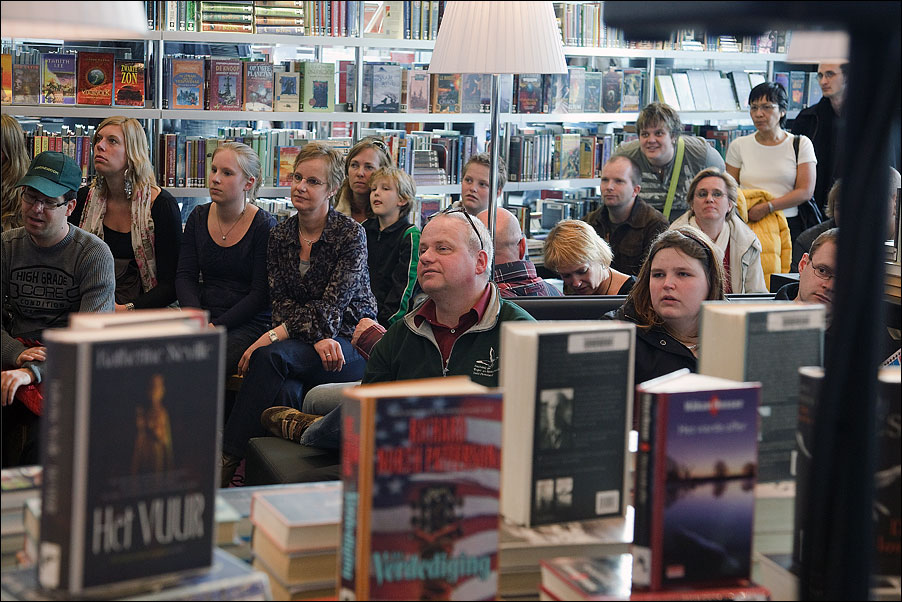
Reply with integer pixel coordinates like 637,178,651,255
175,142,276,382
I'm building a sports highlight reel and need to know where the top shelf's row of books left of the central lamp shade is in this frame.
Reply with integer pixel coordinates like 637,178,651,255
152,0,445,40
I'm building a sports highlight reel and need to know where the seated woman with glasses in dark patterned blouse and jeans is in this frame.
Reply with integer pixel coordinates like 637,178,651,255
221,142,376,486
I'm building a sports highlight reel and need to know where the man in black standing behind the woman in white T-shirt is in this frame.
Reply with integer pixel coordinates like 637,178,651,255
792,63,848,212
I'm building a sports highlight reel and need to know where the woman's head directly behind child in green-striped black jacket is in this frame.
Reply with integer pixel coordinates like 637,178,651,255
335,138,394,223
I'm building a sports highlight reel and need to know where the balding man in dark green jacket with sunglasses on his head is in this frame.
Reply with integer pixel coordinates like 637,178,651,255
261,208,532,449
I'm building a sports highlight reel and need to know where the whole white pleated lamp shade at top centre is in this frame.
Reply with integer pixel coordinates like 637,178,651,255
429,1,567,74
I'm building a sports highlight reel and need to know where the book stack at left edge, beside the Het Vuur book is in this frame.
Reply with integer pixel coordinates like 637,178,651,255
0,466,42,570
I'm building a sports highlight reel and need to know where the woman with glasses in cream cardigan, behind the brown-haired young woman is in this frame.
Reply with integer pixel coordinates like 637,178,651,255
670,167,767,293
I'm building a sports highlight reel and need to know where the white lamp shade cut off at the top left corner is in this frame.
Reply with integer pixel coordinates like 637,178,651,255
0,0,147,40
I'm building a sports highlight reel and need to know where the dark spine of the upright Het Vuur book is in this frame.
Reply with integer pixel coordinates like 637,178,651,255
38,340,83,589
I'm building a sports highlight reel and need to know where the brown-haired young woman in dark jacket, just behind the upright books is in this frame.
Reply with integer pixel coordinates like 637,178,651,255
605,226,724,384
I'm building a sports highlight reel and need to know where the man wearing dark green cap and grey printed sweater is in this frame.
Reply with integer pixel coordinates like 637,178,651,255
0,152,116,467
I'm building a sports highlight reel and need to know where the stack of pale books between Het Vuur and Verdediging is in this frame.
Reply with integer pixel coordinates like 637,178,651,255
250,482,341,600
